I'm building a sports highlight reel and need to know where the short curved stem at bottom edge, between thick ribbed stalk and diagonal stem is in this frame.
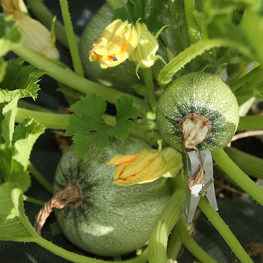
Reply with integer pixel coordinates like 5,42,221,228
175,217,216,263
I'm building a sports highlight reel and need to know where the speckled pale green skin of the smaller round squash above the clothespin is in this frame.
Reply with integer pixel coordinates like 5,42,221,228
156,72,239,154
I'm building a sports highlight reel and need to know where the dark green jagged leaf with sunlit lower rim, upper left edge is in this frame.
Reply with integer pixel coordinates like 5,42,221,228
0,59,45,103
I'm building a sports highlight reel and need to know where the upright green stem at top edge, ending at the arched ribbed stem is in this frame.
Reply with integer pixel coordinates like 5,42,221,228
184,0,200,44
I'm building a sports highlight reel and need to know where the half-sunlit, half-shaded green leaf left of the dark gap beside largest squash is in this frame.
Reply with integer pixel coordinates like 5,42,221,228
13,118,45,169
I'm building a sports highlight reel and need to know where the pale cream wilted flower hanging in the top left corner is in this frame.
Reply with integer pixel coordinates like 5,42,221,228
0,0,59,59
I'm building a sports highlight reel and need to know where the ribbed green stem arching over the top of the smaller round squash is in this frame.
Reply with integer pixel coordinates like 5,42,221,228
158,39,255,88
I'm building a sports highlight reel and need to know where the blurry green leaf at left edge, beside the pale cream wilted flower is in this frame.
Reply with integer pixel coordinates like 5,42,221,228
0,14,22,56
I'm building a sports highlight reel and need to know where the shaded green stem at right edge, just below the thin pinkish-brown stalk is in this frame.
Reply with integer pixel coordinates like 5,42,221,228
224,147,263,179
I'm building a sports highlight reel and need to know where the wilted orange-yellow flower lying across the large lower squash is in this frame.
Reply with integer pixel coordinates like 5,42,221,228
106,141,183,186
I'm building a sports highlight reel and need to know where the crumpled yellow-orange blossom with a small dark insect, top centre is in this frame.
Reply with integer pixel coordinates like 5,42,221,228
89,19,141,68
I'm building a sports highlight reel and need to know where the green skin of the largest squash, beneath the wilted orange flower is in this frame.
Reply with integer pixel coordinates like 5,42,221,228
54,138,172,256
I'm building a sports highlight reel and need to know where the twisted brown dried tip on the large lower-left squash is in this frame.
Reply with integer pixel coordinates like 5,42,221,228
34,180,83,236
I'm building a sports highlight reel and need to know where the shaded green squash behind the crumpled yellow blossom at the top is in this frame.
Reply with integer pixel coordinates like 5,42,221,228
79,3,140,93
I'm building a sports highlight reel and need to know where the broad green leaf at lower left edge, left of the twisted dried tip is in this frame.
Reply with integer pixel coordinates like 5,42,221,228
0,183,33,241
